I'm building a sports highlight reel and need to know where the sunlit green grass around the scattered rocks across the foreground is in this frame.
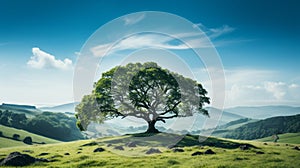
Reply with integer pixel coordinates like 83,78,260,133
0,135,300,168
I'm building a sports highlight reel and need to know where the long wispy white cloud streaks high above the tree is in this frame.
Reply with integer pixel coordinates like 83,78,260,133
91,23,234,57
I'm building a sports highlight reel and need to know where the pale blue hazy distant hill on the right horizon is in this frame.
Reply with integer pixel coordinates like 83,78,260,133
225,106,300,119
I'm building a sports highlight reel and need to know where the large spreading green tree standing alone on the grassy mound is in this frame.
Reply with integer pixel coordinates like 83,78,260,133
76,62,210,133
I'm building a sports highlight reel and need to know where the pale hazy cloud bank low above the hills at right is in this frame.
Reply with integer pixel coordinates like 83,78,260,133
225,81,300,107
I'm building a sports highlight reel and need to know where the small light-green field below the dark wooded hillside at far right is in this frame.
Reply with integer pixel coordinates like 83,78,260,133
257,133,300,144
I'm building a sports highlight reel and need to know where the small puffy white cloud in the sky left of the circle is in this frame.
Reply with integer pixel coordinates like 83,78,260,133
27,47,72,70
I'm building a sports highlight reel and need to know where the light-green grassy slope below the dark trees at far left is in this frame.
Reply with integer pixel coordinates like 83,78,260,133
0,125,60,148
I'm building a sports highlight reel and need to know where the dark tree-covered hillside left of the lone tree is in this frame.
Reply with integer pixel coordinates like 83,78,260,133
0,110,83,141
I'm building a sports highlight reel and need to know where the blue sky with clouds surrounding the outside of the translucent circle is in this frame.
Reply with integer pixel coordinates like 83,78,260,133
0,0,300,106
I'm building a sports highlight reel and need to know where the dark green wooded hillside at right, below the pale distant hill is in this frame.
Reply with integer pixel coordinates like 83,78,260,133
225,115,300,140
